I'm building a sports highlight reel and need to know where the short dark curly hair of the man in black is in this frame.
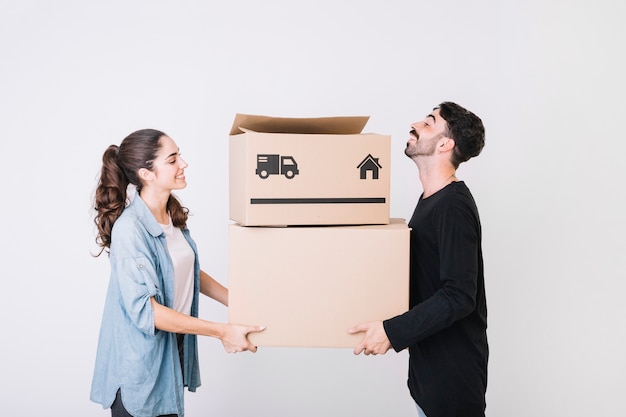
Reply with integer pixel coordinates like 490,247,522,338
435,101,485,168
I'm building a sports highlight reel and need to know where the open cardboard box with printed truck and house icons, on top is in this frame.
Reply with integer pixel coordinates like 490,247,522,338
229,114,391,226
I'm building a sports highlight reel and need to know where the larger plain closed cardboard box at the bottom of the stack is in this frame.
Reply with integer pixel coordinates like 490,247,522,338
228,219,410,348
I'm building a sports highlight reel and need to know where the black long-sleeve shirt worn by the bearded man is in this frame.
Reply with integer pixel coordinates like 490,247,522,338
383,182,489,417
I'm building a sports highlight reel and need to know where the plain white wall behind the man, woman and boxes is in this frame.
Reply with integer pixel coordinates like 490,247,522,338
0,0,626,417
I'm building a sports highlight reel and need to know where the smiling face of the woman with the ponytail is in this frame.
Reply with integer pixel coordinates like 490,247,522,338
152,136,189,190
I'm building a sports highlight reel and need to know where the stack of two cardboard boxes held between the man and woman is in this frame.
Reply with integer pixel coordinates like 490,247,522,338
228,114,409,347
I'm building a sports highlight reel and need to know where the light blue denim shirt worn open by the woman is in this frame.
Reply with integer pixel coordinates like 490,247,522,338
90,194,200,417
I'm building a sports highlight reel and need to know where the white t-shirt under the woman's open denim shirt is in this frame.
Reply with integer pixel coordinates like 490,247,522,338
159,219,194,314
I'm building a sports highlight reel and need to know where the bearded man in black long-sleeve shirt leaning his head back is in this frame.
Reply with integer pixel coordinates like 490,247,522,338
348,102,489,417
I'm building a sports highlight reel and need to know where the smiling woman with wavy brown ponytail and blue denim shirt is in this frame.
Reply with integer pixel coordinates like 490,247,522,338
91,129,264,417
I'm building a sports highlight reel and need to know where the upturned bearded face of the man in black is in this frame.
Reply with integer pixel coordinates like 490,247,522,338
404,109,448,158
